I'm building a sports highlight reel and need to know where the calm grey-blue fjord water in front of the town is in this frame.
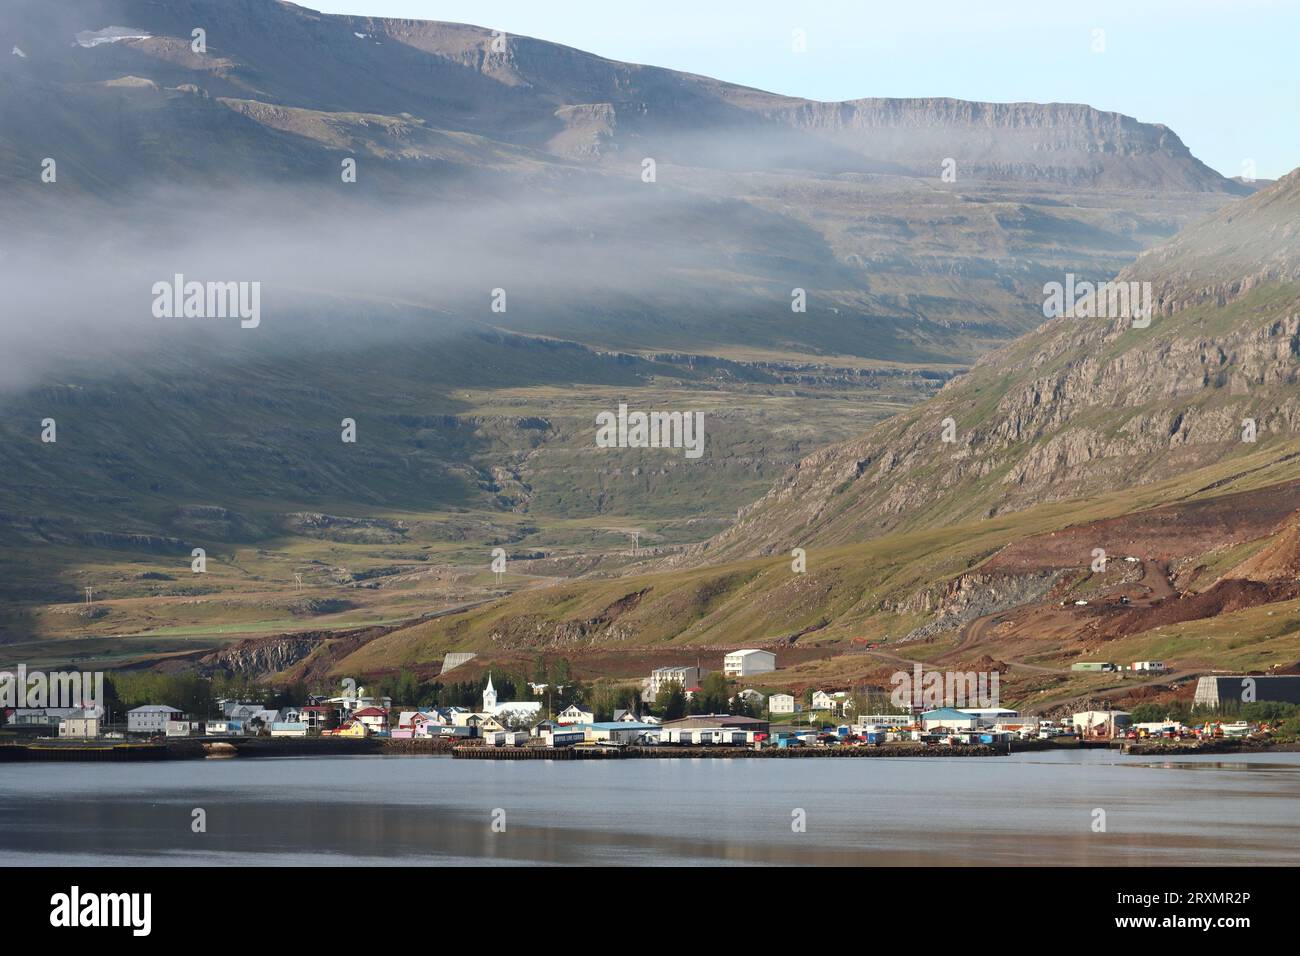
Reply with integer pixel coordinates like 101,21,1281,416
0,750,1300,866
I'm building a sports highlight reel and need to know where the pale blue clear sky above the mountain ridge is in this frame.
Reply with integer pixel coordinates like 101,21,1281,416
302,0,1300,178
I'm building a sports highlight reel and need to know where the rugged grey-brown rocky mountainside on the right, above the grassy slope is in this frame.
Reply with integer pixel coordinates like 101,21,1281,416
690,170,1300,559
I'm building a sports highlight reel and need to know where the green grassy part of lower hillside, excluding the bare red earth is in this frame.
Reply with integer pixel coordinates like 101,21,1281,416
341,442,1300,672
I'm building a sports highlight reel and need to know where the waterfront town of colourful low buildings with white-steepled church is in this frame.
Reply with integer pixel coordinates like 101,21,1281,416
4,648,1300,757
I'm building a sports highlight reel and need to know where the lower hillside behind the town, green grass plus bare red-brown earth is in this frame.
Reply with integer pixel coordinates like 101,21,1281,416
322,441,1300,685
